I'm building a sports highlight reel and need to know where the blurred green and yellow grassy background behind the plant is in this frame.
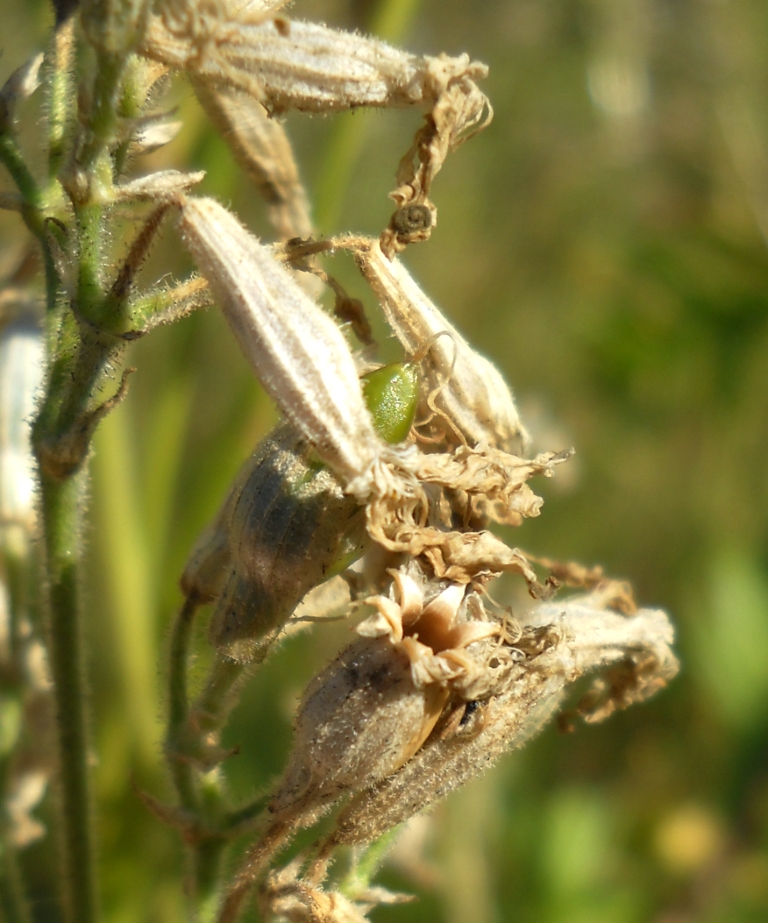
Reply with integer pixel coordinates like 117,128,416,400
0,0,768,923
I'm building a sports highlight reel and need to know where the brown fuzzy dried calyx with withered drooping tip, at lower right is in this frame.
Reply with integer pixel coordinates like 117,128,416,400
325,596,678,852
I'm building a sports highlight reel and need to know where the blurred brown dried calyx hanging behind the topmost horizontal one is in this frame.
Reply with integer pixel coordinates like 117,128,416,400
194,80,312,240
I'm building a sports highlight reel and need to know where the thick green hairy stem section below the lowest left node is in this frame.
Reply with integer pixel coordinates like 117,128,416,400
41,470,98,923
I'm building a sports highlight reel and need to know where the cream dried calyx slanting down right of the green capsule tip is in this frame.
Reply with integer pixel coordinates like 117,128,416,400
352,239,528,451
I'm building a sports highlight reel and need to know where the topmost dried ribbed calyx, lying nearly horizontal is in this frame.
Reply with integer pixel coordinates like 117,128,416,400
142,11,487,112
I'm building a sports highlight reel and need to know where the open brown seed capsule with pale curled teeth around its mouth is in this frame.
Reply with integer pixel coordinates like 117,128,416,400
269,569,503,826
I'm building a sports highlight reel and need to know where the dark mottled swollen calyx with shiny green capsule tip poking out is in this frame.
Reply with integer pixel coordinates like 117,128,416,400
182,363,418,661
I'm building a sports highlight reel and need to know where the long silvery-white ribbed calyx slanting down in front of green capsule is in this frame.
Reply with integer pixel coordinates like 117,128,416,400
179,198,397,484
